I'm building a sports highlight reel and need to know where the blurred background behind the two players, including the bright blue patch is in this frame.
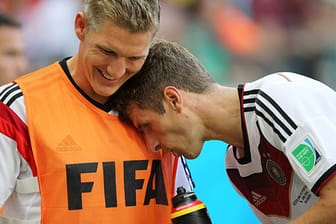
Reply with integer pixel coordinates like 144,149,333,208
0,0,336,224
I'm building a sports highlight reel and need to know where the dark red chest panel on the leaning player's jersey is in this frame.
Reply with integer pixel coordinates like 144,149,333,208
227,132,292,217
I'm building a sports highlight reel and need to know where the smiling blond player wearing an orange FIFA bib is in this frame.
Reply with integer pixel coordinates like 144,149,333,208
0,0,193,224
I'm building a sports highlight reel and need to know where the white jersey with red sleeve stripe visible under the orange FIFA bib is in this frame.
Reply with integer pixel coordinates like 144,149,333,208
0,61,194,224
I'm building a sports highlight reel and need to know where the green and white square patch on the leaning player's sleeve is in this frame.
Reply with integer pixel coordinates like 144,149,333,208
292,136,321,174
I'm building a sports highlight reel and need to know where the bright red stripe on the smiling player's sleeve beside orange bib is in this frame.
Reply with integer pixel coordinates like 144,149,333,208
0,102,37,176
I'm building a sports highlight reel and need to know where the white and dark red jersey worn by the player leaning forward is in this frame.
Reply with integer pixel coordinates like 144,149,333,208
226,73,336,223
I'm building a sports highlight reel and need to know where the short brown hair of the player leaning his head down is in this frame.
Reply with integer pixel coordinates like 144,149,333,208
112,39,215,121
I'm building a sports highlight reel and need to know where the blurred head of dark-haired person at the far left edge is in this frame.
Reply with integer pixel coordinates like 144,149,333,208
0,12,28,85
